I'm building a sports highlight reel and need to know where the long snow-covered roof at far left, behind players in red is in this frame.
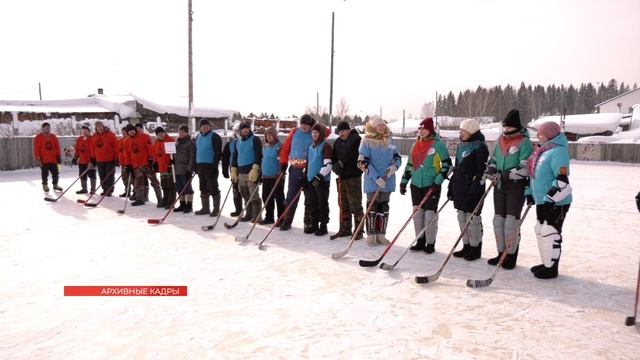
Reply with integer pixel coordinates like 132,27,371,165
0,95,136,118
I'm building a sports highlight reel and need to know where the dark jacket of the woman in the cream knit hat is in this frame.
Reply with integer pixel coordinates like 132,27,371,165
447,131,489,212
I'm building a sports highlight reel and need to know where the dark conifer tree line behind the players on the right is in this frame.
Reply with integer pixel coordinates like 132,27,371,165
436,79,638,123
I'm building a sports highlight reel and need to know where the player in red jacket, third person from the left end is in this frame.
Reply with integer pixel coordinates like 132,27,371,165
91,121,118,196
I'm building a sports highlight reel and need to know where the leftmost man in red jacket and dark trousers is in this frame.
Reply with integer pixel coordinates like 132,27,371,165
33,122,62,192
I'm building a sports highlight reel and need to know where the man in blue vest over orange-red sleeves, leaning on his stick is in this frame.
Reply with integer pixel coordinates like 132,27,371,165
279,114,315,231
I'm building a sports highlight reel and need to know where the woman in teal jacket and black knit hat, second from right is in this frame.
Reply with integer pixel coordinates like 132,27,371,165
487,109,533,270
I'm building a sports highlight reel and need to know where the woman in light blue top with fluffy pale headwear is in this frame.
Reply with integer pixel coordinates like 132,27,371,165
358,116,401,246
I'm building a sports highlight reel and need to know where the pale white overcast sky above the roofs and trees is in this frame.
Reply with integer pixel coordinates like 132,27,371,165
0,0,640,118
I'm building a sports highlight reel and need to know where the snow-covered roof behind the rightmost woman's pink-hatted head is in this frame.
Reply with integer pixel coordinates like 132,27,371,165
529,113,622,135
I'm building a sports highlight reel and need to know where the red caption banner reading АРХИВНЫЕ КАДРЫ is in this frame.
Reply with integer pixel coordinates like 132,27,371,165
64,285,187,296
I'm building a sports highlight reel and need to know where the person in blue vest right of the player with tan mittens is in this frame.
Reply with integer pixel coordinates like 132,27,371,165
260,127,284,225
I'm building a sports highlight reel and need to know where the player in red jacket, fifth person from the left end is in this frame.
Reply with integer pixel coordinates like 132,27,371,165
125,128,162,206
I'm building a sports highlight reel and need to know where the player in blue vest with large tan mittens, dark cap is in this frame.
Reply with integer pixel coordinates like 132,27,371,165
229,120,262,221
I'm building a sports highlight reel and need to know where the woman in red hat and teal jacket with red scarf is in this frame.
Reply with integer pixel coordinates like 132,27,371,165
400,118,451,254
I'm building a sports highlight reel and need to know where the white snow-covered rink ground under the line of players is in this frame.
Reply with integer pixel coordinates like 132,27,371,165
0,162,640,359
